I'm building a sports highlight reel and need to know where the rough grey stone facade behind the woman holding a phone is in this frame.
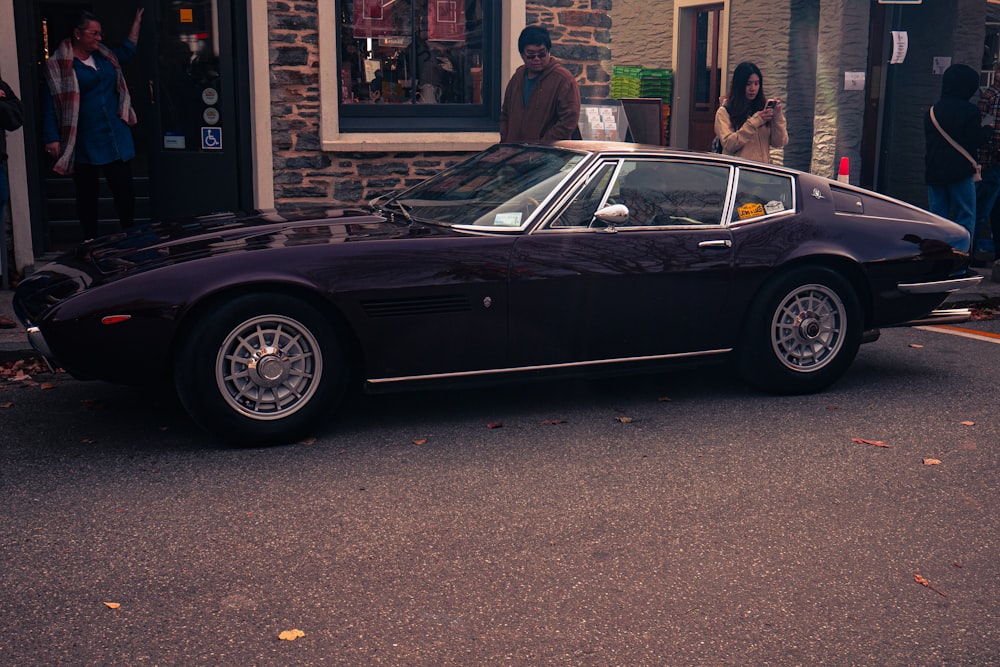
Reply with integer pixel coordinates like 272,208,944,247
611,0,997,206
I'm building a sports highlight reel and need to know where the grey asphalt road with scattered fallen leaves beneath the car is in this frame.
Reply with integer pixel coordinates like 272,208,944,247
0,323,1000,666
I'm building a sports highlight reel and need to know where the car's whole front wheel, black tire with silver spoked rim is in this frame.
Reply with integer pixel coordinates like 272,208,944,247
174,294,346,447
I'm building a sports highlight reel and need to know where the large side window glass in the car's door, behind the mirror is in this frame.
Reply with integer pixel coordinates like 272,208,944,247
609,160,729,227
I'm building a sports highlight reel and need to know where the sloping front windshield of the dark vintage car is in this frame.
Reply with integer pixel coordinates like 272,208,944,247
380,144,586,229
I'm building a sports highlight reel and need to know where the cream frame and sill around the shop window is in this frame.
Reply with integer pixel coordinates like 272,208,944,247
317,0,525,152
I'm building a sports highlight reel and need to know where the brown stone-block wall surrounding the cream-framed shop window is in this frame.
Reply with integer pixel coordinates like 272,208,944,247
268,0,612,208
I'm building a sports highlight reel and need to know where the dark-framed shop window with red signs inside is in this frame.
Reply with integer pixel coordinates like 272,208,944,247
337,0,503,133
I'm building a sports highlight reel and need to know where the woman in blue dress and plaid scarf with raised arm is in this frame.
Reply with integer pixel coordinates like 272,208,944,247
43,9,143,239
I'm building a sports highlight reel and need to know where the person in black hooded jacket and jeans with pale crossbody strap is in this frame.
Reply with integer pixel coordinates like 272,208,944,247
924,65,992,245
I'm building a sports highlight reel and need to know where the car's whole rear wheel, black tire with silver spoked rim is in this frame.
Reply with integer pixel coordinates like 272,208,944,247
737,267,864,394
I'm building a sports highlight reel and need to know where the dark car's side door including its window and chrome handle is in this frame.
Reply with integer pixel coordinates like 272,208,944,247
509,158,736,366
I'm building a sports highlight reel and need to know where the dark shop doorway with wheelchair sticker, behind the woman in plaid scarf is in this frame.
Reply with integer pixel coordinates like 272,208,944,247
18,0,252,252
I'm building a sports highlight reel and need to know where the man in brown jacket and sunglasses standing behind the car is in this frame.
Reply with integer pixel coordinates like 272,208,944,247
500,26,580,142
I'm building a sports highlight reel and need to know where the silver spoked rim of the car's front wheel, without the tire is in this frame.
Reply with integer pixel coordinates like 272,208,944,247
215,315,323,421
